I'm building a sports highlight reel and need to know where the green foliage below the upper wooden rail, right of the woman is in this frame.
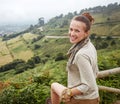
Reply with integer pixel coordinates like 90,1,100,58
97,74,120,104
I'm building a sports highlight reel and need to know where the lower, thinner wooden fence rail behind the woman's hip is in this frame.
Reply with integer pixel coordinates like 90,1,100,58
98,85,120,94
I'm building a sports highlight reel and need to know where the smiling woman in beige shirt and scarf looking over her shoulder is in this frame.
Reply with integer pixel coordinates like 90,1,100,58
51,13,99,104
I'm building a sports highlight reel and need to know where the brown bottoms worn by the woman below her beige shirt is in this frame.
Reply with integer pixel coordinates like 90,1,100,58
65,98,99,104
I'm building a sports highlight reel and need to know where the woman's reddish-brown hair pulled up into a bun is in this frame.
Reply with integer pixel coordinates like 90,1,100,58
73,13,94,31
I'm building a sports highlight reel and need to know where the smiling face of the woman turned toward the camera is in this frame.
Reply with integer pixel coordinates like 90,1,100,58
69,20,88,44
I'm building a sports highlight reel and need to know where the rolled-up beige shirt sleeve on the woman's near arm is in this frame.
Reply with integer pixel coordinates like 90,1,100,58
75,54,96,93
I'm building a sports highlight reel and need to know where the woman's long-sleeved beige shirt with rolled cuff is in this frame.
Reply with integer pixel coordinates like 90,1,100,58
67,41,99,99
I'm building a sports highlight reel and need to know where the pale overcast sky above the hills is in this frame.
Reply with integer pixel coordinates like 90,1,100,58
0,0,120,25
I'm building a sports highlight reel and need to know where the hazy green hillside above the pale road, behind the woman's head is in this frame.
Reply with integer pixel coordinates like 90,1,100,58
44,3,120,35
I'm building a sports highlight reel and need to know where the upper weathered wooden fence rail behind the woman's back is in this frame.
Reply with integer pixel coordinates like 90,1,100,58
97,67,120,78
